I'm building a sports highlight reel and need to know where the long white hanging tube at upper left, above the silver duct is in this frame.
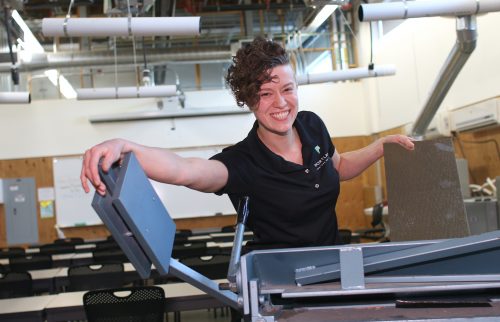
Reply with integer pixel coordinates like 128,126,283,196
42,17,200,37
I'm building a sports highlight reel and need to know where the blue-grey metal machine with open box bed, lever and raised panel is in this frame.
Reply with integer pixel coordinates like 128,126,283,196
92,153,500,322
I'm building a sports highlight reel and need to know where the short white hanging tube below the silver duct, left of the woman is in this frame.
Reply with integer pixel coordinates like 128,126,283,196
76,85,177,100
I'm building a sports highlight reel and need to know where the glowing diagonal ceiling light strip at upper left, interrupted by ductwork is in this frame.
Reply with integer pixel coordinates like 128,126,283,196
12,10,76,98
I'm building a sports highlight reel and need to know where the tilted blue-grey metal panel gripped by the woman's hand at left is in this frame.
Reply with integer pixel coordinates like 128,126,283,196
92,153,175,278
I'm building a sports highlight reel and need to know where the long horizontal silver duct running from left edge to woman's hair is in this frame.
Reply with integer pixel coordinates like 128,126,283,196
0,46,231,73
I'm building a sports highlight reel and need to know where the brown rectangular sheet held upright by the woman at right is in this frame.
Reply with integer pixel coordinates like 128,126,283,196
384,138,469,241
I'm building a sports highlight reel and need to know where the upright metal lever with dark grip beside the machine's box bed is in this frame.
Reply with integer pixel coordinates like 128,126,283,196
227,196,250,292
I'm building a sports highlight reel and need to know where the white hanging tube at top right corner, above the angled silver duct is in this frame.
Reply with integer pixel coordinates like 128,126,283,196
358,0,500,21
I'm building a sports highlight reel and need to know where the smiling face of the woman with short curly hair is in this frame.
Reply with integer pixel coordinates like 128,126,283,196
253,65,298,135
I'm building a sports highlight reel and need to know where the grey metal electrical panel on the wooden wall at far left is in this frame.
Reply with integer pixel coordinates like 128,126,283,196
3,178,38,245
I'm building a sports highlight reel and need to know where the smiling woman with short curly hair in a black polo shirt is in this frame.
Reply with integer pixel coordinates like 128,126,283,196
81,38,413,250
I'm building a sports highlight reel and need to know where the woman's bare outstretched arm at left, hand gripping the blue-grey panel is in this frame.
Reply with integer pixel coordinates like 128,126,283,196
80,139,228,195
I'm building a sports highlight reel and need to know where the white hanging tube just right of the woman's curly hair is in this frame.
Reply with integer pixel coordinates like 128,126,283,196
297,65,396,85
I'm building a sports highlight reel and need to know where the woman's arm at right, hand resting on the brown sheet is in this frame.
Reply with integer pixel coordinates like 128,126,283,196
332,134,415,181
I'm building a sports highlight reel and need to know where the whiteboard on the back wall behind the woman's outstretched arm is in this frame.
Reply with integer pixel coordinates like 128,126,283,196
53,147,236,227
